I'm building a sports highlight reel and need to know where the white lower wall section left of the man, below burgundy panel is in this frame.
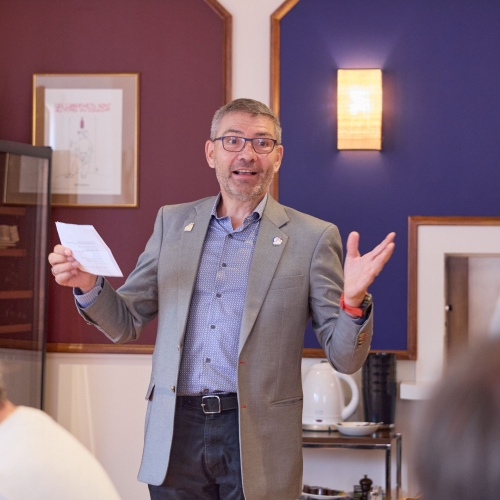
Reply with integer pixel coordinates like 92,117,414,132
45,353,151,500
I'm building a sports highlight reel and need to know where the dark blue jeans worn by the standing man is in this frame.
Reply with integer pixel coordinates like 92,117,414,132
149,397,245,500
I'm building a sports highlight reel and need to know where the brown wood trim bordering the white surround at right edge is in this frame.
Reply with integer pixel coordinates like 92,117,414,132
406,216,500,359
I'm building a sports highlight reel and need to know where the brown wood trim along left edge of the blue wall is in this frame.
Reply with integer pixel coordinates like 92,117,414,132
269,0,300,199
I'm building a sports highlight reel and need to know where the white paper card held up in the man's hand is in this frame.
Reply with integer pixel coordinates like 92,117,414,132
56,222,123,276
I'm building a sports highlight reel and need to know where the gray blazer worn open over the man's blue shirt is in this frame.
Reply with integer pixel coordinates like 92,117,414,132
80,197,372,500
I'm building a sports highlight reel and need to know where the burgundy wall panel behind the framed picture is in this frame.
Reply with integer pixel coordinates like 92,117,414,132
0,0,223,344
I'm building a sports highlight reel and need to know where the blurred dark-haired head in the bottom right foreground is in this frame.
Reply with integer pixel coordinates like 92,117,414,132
415,338,500,500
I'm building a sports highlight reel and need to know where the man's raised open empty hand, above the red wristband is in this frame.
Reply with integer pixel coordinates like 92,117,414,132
344,231,396,307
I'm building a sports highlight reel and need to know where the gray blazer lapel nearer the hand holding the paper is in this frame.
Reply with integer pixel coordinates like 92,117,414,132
177,197,215,338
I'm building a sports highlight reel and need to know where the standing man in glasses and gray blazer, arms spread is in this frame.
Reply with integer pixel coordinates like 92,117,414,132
49,99,394,500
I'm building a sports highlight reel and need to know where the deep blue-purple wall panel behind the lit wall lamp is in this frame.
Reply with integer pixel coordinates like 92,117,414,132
279,0,500,349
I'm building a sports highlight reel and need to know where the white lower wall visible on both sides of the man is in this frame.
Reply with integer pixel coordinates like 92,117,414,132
45,353,420,500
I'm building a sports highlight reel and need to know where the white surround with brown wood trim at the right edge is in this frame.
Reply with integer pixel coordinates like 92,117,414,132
408,216,500,368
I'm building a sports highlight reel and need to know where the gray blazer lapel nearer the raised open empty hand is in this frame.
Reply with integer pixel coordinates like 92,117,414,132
238,196,289,354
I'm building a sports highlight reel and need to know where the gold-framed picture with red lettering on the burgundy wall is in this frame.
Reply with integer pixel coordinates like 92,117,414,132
33,73,139,207
